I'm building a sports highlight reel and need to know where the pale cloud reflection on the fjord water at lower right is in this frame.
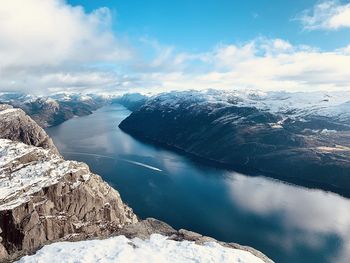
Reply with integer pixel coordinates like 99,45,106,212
226,174,350,262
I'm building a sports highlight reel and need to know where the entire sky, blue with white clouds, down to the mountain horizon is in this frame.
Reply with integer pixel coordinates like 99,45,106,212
0,0,350,94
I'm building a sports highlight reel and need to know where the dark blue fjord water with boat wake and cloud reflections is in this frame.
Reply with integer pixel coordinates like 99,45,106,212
47,105,350,263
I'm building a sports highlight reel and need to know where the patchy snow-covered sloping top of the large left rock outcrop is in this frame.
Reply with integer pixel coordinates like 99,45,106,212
0,139,82,211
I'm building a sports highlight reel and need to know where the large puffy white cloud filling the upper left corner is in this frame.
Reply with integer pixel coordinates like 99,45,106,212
0,0,132,95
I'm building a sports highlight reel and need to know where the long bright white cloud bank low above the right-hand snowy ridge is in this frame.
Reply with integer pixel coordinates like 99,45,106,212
136,38,350,94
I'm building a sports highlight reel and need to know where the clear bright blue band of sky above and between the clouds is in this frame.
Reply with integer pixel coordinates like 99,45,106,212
68,0,350,51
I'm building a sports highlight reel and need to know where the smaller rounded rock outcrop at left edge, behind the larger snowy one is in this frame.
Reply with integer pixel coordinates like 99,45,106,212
0,104,58,153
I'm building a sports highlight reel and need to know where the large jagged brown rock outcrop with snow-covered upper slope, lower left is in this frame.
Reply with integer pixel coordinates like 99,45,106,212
0,139,137,261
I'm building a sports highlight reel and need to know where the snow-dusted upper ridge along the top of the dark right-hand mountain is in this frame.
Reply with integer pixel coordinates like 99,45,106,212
148,89,350,120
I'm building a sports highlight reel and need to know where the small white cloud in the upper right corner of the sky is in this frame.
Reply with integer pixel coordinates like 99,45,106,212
297,1,350,30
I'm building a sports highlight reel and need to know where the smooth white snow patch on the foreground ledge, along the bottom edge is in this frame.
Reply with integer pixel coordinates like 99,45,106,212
18,234,263,263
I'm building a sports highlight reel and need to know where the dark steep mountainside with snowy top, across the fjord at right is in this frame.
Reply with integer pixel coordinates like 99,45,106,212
120,90,350,194
